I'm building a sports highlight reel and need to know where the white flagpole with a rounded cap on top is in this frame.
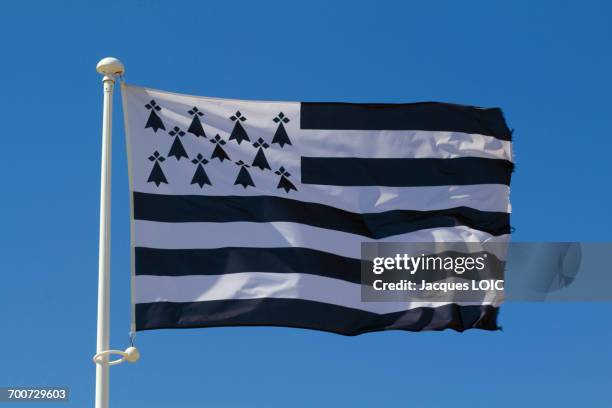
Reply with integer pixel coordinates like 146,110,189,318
95,58,125,408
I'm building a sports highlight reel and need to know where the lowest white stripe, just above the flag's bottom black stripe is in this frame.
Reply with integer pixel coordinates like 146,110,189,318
135,272,496,314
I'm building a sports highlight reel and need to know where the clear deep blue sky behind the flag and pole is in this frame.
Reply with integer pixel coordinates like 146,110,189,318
0,0,612,407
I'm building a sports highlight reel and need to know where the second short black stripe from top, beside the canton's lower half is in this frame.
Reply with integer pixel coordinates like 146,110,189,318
301,157,513,187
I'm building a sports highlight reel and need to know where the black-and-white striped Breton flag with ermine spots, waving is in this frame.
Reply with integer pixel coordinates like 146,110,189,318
122,84,513,335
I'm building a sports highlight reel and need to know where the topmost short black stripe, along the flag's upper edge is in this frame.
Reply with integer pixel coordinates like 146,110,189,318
300,102,511,140
